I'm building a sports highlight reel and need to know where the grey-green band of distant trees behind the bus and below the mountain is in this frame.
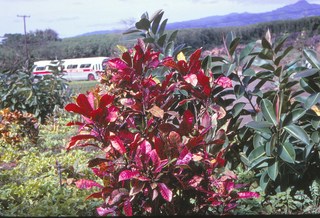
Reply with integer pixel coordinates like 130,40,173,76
0,16,320,71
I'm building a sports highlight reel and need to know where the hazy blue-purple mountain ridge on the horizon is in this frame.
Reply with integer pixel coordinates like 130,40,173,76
79,0,320,35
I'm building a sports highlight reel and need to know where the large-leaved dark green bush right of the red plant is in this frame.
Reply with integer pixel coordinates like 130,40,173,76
213,29,320,194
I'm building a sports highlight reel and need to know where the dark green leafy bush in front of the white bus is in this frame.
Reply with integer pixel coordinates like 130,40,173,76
0,65,69,123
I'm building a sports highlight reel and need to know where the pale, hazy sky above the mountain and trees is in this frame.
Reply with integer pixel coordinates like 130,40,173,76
0,0,320,38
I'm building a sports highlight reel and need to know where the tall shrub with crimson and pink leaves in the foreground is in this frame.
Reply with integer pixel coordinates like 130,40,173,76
65,41,258,216
